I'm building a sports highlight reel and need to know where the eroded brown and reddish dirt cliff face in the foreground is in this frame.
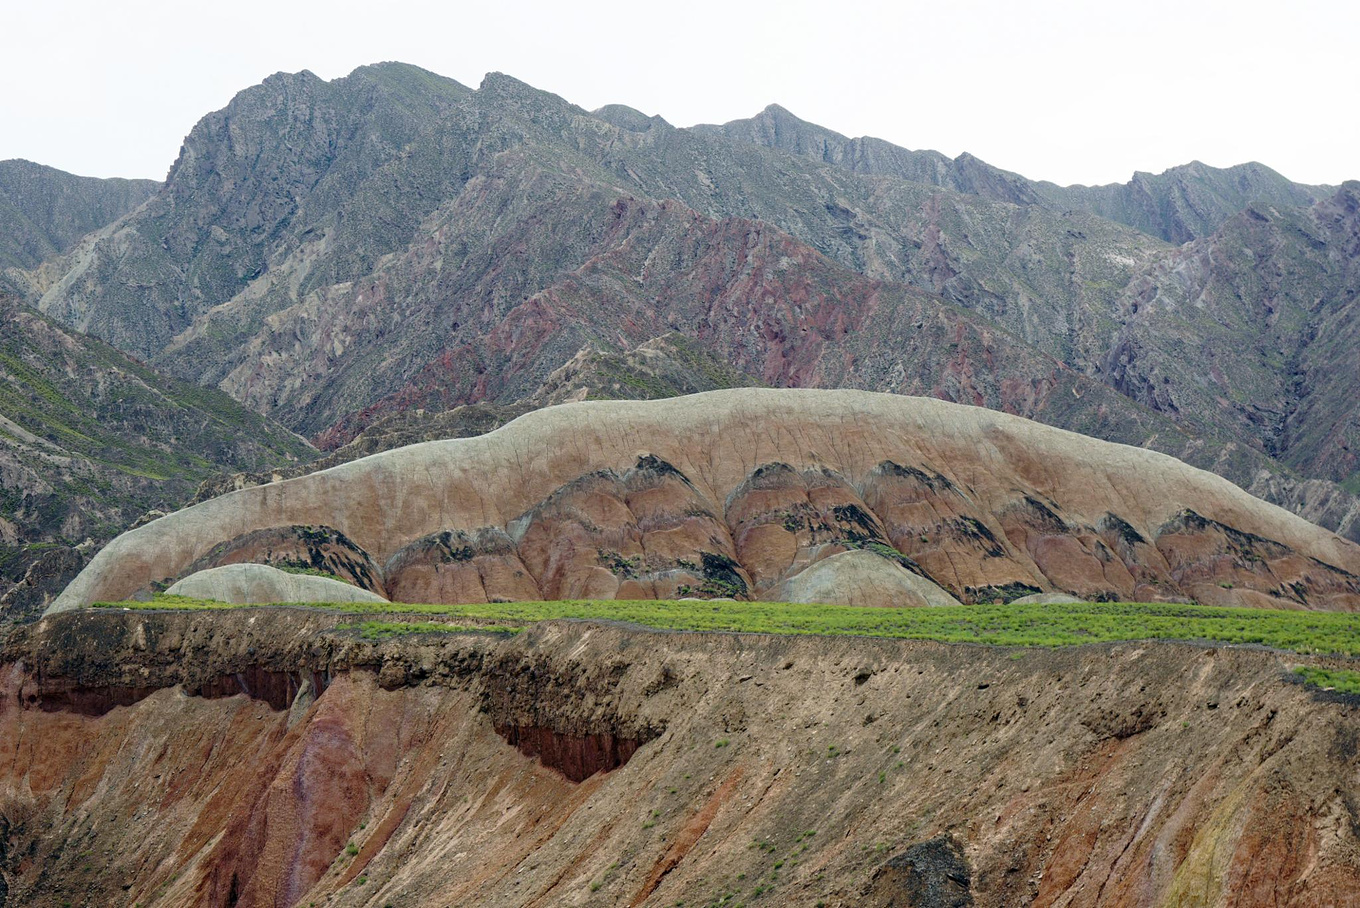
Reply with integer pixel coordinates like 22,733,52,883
0,609,1360,908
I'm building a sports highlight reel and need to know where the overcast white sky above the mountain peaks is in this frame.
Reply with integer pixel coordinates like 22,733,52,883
0,0,1360,184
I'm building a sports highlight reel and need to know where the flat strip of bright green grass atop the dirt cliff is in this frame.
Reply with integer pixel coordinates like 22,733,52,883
95,595,1360,655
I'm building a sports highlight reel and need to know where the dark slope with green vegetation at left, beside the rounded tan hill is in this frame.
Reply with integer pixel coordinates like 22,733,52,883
0,295,316,544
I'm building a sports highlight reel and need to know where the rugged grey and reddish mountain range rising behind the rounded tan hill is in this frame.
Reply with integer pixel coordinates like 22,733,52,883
0,64,1360,608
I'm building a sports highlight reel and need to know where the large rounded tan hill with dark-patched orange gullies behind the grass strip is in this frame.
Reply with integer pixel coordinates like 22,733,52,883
50,389,1360,612
